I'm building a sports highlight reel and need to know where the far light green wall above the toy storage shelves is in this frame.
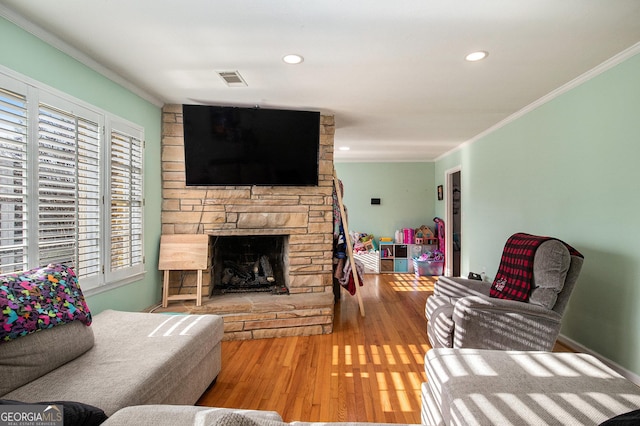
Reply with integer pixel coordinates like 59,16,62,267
335,163,436,243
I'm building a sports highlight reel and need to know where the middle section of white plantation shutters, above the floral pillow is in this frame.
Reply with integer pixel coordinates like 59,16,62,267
37,104,100,277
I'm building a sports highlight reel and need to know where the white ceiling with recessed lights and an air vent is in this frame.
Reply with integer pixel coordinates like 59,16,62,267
0,0,640,161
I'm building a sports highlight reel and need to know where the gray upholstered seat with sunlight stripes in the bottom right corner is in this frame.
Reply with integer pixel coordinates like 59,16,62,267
422,348,640,426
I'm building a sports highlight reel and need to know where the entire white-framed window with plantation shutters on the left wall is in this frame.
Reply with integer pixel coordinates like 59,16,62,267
0,70,144,290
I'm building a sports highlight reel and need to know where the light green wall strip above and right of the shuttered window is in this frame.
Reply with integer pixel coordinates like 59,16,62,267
0,18,162,313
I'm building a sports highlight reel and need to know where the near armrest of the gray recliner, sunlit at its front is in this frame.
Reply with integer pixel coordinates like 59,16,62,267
453,296,561,351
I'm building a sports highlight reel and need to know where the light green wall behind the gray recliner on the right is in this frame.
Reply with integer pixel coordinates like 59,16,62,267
435,51,640,373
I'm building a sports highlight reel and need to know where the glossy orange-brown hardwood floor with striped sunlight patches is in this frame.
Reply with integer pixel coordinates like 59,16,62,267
198,274,434,423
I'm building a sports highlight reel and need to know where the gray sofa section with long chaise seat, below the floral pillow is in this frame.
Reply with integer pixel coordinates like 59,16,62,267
0,310,224,416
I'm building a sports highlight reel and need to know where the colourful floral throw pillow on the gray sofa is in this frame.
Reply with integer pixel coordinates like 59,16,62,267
0,264,91,342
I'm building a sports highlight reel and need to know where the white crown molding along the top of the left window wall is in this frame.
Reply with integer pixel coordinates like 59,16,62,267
0,4,164,108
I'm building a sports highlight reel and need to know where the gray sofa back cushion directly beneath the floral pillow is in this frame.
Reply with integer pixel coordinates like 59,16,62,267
0,321,94,396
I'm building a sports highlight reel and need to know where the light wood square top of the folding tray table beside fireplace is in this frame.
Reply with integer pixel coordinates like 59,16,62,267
158,234,209,271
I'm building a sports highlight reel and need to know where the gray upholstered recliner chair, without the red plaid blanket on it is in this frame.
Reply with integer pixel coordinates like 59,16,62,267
425,240,583,351
